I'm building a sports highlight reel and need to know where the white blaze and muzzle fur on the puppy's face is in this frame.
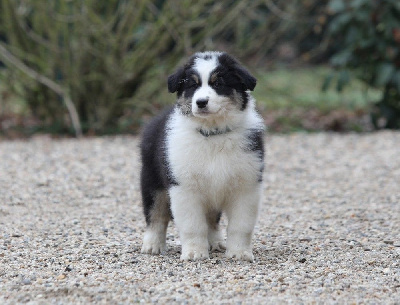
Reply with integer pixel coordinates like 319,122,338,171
192,55,225,116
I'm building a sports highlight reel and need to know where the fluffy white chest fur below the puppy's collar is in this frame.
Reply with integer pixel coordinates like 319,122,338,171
166,106,261,206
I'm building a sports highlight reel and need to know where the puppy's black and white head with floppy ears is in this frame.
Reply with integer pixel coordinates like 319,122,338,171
168,52,256,118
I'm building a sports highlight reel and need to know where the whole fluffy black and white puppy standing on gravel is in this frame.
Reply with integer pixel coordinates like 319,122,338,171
141,52,264,261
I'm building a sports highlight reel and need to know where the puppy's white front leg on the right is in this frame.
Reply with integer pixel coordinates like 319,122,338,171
226,186,261,262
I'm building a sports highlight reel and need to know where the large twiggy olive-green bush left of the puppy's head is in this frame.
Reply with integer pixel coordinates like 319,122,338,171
1,0,185,132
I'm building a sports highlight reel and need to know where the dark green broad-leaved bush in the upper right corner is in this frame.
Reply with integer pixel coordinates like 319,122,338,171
325,0,400,129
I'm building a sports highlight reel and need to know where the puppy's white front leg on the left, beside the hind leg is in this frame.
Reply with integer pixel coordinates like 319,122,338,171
170,186,209,260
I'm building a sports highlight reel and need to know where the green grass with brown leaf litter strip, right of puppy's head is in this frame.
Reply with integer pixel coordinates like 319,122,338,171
253,66,382,132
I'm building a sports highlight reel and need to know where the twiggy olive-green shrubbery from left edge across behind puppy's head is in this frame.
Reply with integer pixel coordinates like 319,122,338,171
0,0,327,133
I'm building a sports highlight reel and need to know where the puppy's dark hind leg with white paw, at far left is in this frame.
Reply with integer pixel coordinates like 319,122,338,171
141,190,171,254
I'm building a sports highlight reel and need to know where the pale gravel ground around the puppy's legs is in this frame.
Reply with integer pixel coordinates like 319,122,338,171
0,132,400,304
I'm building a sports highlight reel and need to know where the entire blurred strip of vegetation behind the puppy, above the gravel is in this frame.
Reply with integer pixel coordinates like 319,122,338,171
0,0,400,137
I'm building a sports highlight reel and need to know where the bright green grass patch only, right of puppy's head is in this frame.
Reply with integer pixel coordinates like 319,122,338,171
253,66,382,113
